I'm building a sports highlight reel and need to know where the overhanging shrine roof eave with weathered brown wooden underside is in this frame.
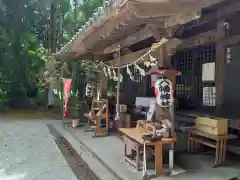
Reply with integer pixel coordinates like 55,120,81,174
54,0,223,60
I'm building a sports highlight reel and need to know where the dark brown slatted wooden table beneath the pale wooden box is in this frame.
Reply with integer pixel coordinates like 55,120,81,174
187,128,237,167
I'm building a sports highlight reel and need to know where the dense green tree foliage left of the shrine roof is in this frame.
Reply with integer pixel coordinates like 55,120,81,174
0,0,102,109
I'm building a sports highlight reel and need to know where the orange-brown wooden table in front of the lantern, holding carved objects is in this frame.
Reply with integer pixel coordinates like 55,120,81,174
119,128,176,175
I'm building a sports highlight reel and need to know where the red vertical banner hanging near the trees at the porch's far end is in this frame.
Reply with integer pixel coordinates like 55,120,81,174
63,79,72,117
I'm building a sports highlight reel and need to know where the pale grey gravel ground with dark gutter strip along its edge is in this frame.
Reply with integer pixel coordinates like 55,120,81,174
0,119,97,180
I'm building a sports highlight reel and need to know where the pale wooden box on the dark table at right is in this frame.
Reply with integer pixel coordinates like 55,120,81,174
196,117,228,136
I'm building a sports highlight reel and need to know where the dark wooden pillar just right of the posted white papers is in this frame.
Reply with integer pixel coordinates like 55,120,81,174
215,20,226,110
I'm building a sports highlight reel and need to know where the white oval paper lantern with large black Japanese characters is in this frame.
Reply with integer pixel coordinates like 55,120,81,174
154,78,173,108
